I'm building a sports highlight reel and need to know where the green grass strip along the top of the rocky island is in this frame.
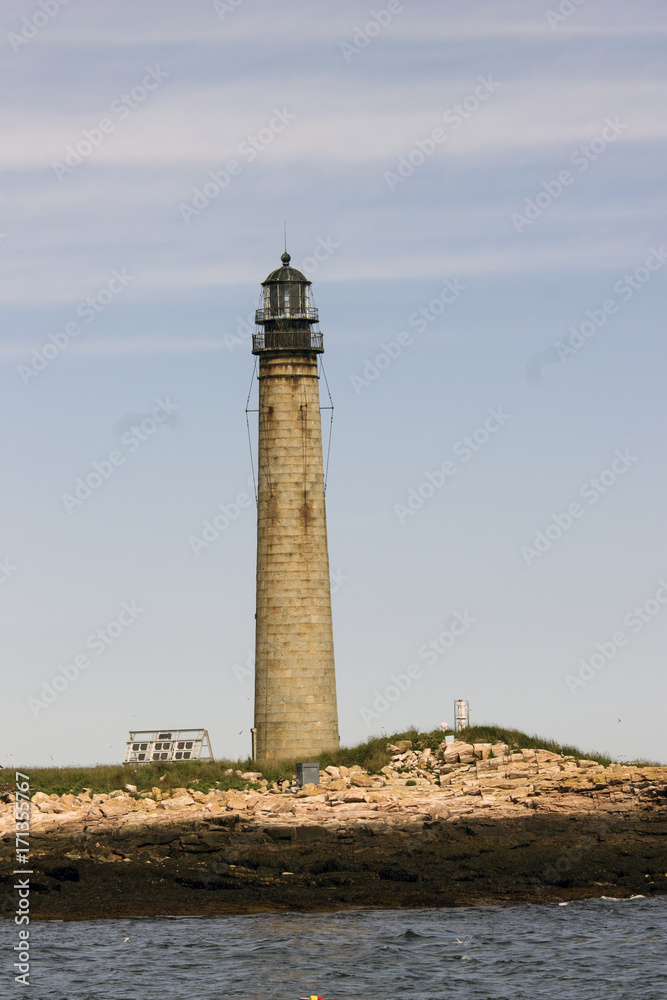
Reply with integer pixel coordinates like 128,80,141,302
9,725,656,795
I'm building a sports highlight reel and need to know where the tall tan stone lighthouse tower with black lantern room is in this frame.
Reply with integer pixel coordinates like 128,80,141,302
253,251,339,760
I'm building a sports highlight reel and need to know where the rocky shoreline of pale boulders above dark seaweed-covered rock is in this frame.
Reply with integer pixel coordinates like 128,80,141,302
0,741,667,920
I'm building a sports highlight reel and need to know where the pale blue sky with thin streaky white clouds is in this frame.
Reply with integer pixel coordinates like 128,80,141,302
0,0,667,767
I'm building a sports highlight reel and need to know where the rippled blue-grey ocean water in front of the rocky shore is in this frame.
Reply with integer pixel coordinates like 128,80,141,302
0,897,667,1000
